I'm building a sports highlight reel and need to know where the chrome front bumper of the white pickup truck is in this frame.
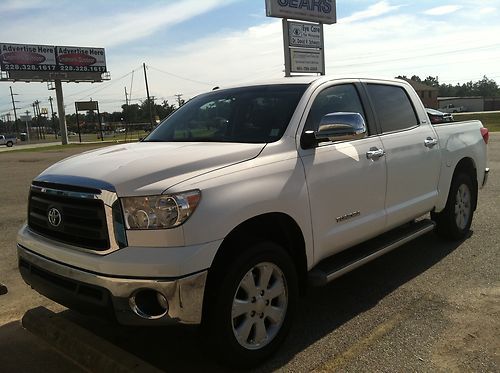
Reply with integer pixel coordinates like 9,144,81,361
17,244,208,325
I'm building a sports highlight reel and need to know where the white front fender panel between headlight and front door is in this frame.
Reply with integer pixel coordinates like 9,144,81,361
168,152,313,267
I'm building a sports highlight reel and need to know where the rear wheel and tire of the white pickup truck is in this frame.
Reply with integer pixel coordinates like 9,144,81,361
431,172,477,241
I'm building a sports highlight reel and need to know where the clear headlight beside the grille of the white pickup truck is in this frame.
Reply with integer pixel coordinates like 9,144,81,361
121,190,201,229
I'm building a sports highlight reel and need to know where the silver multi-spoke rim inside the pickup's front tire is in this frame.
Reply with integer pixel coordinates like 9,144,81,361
231,262,288,350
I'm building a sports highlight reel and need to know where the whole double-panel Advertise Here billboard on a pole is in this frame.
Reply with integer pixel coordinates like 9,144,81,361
0,43,107,73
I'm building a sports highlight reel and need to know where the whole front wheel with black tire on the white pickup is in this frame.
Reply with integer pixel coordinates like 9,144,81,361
203,242,298,367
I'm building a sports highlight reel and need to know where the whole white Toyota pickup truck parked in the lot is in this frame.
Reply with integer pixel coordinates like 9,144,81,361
17,77,488,365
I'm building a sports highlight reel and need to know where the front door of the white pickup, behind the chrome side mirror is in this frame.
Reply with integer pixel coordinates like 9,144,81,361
298,82,386,262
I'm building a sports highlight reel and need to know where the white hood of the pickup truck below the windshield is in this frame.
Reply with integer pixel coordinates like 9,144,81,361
35,142,265,196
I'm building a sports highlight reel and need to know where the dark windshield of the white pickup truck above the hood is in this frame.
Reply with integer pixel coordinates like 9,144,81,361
144,84,307,143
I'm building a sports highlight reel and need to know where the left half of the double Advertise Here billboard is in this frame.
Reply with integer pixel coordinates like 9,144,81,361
0,43,57,71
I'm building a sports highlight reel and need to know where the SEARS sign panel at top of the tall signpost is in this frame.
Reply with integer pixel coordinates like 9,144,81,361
266,0,337,24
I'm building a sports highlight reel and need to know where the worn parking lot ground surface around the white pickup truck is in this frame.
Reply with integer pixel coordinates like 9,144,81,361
0,134,500,372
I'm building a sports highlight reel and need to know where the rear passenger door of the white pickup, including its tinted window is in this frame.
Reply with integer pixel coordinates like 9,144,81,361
365,82,441,229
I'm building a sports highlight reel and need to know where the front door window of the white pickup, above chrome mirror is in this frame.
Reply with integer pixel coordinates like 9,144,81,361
304,84,366,131
